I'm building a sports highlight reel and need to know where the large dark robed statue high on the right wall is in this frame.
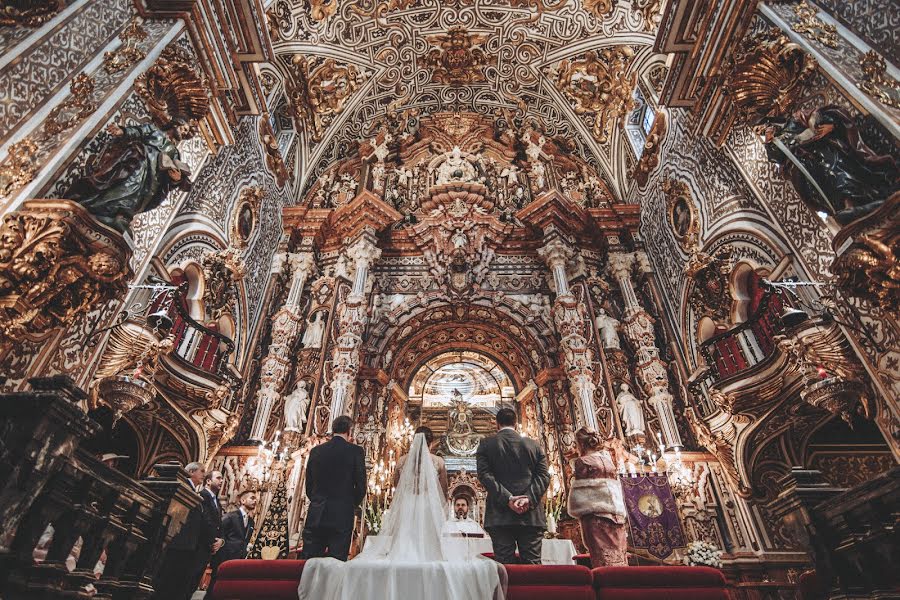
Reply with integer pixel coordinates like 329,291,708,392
759,106,900,225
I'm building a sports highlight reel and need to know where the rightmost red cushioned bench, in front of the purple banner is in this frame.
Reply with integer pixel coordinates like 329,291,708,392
591,566,728,600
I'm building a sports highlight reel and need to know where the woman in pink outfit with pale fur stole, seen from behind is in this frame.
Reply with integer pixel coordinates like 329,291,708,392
568,427,637,567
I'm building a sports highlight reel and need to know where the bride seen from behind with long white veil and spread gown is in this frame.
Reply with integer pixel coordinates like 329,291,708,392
299,433,506,600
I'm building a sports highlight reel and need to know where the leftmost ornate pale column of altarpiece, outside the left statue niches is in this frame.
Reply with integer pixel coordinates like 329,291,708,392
250,252,316,442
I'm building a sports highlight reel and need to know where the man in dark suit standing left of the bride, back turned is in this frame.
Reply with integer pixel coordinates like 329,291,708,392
301,416,366,560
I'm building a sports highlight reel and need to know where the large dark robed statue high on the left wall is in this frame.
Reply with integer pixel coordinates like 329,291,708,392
64,123,191,233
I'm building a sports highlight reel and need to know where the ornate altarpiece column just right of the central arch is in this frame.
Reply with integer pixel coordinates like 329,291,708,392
538,229,599,431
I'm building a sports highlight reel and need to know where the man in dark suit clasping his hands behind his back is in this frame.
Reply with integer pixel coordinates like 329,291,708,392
475,408,550,565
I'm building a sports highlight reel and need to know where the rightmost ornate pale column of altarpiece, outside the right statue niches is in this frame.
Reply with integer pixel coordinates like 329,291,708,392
609,254,681,448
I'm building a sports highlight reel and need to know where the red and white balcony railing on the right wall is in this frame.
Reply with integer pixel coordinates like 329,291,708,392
700,291,784,381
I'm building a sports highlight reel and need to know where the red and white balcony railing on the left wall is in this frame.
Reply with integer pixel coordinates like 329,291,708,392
147,283,234,377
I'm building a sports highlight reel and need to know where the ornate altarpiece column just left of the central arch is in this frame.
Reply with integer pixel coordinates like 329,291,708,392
329,232,381,430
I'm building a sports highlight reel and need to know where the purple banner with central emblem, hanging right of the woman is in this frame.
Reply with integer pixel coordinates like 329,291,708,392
619,475,685,558
